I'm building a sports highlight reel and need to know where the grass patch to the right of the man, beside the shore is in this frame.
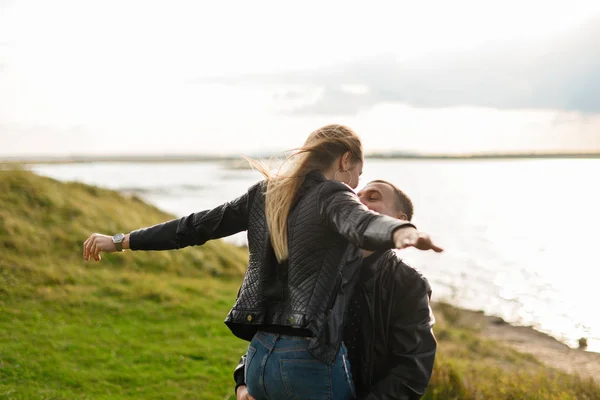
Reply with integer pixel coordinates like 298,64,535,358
424,303,600,400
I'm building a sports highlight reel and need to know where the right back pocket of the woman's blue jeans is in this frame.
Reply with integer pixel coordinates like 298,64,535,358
279,360,332,400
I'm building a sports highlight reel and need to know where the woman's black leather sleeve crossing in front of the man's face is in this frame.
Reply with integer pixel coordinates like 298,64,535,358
319,180,415,251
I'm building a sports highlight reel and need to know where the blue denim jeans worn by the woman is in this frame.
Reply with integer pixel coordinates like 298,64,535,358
245,332,356,400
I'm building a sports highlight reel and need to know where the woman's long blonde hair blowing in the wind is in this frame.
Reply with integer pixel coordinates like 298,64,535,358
246,124,363,262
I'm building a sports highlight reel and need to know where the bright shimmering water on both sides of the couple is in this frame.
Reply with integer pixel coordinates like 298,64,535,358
32,159,600,351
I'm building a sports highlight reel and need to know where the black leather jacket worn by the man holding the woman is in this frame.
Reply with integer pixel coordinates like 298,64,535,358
234,251,437,400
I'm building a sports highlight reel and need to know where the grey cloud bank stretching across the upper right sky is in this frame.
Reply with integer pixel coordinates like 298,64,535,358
199,19,600,115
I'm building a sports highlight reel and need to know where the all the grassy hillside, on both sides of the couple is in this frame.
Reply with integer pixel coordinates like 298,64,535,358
0,171,600,400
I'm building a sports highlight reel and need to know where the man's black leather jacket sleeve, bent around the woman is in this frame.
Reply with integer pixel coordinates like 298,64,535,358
364,266,437,400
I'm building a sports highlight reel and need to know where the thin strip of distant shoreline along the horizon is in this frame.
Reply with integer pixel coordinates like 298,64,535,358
0,153,600,164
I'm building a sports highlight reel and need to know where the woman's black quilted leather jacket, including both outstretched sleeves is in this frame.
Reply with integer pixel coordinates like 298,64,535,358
129,171,412,363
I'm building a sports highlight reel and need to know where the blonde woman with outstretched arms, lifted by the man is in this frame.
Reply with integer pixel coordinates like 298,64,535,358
84,125,442,400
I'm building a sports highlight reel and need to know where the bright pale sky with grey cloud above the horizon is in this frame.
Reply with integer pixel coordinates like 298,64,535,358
0,0,600,156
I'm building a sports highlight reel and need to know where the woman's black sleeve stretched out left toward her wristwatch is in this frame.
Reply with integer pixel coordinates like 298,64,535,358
129,184,260,250
